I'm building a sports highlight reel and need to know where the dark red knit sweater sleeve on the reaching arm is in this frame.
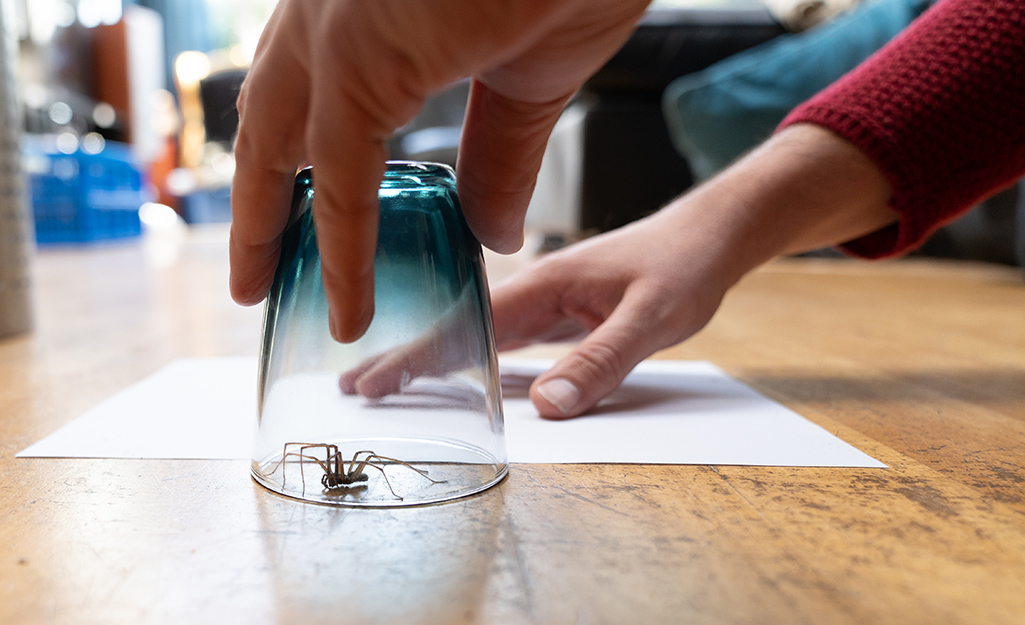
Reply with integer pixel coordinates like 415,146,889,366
780,0,1025,258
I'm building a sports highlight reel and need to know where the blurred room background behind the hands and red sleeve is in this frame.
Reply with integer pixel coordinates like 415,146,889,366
4,0,1025,263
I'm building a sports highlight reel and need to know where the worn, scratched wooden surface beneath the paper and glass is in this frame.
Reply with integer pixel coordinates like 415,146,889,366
0,227,1025,625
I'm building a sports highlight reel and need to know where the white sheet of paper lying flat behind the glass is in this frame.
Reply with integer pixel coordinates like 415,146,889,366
18,358,886,467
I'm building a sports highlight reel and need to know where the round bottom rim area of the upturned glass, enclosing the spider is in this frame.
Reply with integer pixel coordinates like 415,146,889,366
252,438,508,507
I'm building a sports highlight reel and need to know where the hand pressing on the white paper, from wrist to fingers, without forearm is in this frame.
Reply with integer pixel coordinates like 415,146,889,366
492,204,739,418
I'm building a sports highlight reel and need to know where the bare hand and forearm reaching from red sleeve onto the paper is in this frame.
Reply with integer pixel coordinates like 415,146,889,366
492,125,896,418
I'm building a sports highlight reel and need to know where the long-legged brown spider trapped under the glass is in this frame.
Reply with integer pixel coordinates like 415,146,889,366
271,443,445,501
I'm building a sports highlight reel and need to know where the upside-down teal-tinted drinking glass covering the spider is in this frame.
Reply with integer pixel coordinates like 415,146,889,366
252,162,507,506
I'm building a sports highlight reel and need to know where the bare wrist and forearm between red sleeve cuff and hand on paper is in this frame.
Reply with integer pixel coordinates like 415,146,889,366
662,124,897,284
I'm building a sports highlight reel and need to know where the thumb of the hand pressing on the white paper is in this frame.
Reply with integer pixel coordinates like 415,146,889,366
530,313,658,419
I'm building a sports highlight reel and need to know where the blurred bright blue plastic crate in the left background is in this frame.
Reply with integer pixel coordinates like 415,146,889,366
23,141,150,245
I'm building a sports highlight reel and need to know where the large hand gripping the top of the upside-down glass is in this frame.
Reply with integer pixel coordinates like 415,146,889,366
231,0,649,341
